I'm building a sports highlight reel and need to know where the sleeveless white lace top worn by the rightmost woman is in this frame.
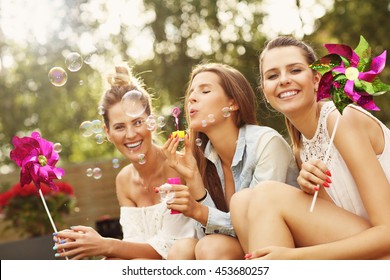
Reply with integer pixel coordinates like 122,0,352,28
300,102,390,218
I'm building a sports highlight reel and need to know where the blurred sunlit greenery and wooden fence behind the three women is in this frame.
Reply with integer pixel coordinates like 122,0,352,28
0,0,390,245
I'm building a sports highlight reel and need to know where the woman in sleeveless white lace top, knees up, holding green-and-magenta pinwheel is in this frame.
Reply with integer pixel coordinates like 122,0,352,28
231,37,390,259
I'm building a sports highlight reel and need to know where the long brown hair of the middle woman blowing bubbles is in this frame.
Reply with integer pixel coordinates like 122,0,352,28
185,63,257,212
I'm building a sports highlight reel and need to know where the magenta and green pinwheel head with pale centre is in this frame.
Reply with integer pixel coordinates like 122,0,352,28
310,36,390,113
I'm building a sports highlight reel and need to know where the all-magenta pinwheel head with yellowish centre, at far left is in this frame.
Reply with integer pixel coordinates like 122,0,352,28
10,132,65,190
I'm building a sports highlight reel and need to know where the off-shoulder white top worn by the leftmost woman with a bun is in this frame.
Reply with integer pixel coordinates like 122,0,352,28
119,203,204,259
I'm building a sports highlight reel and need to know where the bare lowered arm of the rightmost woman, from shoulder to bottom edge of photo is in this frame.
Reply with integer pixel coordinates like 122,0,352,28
292,107,390,259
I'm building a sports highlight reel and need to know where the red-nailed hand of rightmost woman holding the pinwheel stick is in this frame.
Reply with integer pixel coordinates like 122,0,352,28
297,159,332,194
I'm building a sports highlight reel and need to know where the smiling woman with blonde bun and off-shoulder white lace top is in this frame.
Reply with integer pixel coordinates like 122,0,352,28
54,67,204,259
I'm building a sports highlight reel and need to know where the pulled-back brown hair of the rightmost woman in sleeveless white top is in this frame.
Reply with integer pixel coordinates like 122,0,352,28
259,36,317,152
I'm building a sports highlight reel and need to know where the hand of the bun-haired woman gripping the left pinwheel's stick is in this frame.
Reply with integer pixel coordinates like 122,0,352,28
53,226,107,260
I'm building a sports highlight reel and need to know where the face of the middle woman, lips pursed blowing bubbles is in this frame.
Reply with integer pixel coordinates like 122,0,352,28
187,71,238,132
